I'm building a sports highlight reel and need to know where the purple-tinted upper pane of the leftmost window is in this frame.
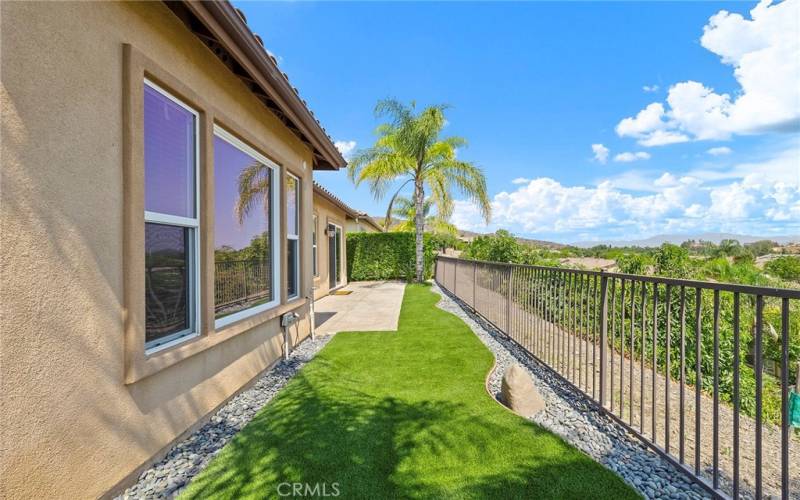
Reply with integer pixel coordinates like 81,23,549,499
144,85,195,218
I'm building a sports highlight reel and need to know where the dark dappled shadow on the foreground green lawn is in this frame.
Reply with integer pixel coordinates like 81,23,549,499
185,368,472,498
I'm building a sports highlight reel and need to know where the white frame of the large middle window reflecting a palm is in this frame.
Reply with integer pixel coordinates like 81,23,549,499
212,123,281,330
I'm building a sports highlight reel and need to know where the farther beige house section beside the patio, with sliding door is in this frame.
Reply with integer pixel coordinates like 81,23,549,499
311,182,383,299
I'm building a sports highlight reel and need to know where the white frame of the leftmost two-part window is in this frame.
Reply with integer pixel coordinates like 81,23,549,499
142,78,201,355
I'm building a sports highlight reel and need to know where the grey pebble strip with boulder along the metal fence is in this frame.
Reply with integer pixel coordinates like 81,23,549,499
432,283,711,499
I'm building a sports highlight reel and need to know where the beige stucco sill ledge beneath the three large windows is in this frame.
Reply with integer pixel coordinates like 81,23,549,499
125,298,308,384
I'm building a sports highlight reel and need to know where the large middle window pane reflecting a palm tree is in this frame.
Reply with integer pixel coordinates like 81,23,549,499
214,137,273,318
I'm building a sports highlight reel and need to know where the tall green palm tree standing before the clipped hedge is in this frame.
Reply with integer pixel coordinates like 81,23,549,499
348,99,491,281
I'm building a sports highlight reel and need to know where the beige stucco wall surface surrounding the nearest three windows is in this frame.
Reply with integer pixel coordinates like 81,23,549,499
0,2,324,498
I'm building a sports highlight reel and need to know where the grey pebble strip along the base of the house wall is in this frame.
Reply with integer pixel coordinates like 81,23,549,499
115,335,333,500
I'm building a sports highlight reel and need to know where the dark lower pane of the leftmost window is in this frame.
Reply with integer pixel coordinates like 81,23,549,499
145,223,192,343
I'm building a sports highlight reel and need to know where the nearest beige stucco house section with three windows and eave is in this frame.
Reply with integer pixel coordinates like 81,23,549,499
0,1,345,498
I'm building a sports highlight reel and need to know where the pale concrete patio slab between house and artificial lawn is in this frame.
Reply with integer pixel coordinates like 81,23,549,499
314,281,406,335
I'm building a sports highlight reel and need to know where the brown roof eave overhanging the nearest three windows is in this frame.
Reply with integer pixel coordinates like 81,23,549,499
164,0,347,170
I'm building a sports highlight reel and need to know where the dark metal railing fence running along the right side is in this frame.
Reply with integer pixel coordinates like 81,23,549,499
436,256,800,499
